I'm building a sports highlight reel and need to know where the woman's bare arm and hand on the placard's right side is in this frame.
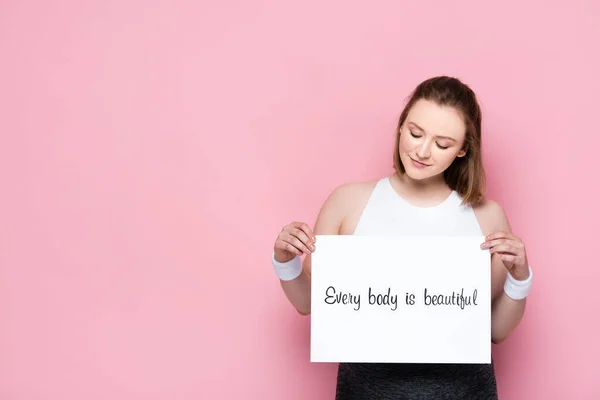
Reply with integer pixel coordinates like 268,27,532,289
484,203,529,344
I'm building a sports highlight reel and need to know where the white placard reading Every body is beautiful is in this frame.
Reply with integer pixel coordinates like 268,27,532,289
310,235,491,364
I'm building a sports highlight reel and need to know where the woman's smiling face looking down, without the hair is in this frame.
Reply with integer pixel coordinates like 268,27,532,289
398,99,466,180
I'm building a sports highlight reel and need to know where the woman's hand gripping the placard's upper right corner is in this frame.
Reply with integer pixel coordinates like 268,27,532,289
481,231,529,280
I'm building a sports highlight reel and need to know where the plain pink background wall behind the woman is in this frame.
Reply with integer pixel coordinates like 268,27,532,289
0,0,600,400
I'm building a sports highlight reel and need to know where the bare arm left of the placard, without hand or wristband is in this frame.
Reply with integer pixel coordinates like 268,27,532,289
280,186,346,315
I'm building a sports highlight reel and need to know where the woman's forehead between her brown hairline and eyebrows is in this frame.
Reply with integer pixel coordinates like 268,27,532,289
406,99,466,140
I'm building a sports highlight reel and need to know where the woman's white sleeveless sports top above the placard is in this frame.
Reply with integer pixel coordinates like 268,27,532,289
354,177,483,236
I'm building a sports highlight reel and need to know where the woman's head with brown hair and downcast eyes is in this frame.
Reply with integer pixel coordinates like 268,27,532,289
393,77,486,209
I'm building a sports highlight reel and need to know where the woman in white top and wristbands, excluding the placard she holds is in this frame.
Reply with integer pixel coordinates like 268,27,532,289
271,76,533,400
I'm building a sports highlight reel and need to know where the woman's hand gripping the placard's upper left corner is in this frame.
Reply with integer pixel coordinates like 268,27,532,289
274,222,316,262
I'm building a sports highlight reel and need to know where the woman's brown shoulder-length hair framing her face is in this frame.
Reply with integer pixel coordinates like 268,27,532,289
394,76,486,205
